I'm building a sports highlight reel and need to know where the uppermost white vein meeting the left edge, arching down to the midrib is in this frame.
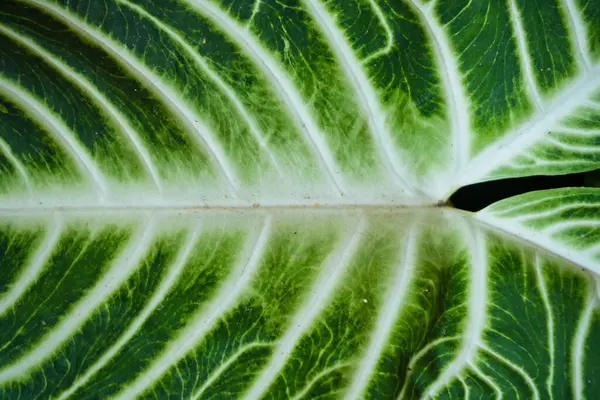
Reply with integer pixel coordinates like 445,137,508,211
0,24,162,193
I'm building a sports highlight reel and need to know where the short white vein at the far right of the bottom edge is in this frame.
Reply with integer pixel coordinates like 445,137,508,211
571,291,596,400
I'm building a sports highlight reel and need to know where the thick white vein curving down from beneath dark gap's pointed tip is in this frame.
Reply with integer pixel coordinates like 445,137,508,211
424,226,488,398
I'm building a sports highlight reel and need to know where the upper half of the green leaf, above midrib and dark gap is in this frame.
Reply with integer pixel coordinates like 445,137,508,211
0,0,600,208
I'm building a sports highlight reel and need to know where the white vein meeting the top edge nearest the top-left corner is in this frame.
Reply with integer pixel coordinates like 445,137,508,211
24,0,239,190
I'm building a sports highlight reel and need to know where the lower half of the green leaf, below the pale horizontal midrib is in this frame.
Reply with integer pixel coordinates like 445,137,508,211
0,210,600,399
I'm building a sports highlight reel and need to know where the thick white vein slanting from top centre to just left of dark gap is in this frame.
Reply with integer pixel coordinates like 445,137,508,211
305,0,416,192
